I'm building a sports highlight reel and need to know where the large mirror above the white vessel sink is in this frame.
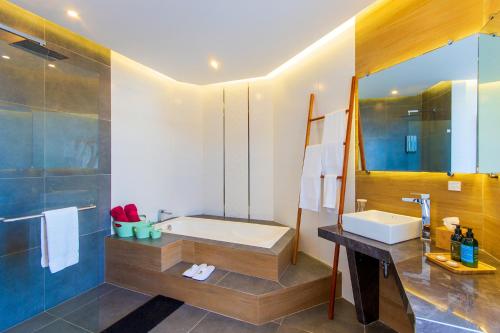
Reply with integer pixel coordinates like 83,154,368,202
359,35,478,172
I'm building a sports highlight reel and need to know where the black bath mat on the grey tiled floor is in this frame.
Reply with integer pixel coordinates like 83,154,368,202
101,295,184,333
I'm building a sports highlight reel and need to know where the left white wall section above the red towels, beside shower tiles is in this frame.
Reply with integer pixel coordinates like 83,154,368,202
111,52,203,220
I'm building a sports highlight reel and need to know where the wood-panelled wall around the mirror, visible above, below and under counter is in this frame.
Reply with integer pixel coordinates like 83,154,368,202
356,0,500,332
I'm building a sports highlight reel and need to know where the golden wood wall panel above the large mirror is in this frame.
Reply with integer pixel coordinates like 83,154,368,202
356,0,484,77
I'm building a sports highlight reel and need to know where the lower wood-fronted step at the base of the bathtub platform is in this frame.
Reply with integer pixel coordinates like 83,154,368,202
106,253,342,325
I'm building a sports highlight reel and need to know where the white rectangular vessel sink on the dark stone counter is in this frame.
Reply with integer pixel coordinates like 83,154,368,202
342,210,422,244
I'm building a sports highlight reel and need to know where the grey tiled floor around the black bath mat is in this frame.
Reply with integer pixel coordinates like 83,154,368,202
2,284,394,333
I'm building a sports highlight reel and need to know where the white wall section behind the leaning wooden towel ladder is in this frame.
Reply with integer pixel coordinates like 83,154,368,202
272,22,355,302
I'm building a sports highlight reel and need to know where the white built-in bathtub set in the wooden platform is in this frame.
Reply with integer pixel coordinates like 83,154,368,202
156,217,290,248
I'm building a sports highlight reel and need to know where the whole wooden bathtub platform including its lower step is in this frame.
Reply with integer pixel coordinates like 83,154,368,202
106,217,342,325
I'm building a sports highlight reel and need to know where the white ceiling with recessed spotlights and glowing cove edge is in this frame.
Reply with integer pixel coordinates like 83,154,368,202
12,0,374,84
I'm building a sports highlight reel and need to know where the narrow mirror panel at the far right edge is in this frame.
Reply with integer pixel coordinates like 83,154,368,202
478,15,500,173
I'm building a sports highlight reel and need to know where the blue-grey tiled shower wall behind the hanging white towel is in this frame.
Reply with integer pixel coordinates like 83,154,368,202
0,0,111,331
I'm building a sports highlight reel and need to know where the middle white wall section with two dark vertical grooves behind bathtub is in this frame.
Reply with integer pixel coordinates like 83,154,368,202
203,80,274,220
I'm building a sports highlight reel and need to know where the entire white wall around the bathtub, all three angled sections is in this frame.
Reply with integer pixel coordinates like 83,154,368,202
112,19,355,302
